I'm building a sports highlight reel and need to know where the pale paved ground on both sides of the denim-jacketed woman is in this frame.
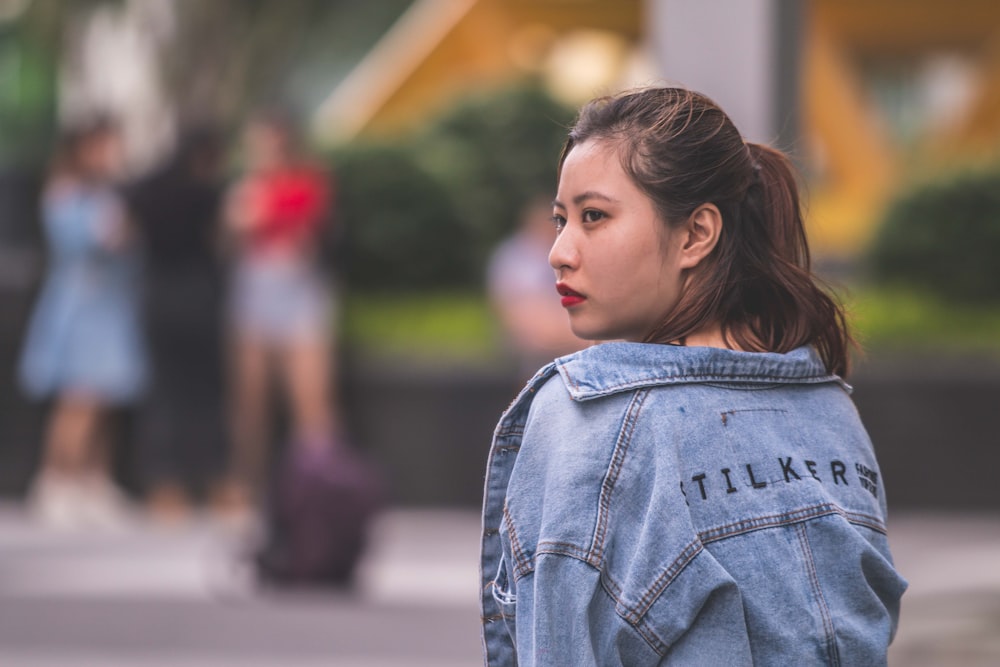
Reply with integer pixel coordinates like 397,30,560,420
0,506,1000,667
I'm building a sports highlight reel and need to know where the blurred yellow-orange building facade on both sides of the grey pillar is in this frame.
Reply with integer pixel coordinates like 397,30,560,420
315,0,1000,256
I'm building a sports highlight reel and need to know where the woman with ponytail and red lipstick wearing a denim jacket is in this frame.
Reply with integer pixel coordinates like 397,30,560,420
481,88,906,667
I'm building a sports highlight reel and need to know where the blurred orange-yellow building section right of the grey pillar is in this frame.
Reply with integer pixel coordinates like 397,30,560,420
801,0,1000,254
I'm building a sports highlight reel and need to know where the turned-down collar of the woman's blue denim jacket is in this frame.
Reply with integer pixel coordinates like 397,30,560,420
555,342,851,401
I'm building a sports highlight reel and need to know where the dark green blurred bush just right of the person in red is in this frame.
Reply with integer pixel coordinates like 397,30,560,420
333,145,473,291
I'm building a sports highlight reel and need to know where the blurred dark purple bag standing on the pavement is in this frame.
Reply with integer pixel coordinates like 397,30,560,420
257,442,385,585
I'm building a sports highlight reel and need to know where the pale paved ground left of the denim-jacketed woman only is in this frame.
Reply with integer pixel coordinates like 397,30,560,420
0,507,480,667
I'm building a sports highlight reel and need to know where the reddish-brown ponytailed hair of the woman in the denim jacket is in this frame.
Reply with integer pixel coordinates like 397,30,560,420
559,88,853,375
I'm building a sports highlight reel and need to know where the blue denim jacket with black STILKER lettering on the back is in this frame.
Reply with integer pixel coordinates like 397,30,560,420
481,343,906,667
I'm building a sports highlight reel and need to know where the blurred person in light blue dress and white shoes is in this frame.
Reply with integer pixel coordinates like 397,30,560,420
19,116,146,527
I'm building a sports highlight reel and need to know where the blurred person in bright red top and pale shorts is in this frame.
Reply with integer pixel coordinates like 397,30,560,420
225,113,339,504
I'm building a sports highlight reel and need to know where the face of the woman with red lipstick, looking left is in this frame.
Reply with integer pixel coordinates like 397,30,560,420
549,140,683,341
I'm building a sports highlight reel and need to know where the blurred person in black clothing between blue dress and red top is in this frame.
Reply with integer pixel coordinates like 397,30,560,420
127,127,227,519
